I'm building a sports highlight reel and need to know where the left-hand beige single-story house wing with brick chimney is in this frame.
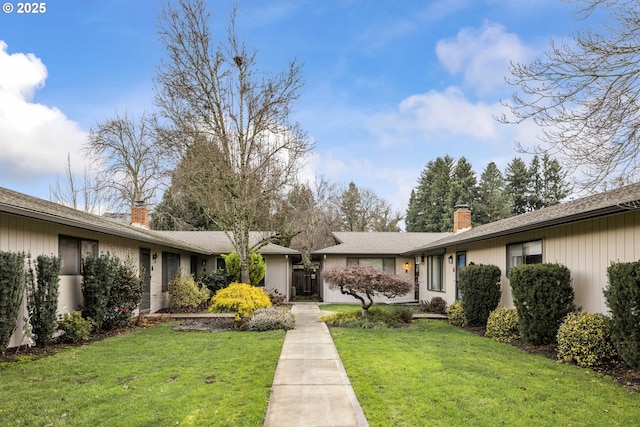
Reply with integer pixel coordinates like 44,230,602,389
0,187,298,347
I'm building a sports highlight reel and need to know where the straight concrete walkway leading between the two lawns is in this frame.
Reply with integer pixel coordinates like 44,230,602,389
264,303,369,427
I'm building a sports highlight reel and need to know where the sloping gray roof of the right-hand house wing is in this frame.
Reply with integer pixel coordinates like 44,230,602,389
407,183,640,254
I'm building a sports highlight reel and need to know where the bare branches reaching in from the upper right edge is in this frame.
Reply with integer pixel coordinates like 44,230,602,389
499,0,640,190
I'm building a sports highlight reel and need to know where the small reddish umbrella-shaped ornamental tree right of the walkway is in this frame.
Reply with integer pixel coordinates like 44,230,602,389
324,265,413,317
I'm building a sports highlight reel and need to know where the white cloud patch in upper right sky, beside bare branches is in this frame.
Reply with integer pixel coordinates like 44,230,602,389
436,24,532,95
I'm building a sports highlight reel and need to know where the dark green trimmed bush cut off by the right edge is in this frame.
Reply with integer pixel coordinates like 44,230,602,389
604,262,640,369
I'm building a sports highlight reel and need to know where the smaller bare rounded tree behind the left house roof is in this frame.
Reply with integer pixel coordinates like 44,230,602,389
83,113,169,209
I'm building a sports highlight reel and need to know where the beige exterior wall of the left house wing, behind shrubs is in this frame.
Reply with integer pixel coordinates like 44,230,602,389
0,213,195,347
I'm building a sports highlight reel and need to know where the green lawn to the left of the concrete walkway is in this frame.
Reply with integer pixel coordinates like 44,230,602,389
0,324,284,426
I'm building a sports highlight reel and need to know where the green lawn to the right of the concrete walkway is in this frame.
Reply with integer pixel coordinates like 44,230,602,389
331,320,640,427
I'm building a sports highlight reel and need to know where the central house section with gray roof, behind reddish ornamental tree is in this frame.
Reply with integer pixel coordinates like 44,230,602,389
313,232,451,303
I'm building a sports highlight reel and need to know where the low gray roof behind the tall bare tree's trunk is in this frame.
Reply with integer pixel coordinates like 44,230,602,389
156,231,300,255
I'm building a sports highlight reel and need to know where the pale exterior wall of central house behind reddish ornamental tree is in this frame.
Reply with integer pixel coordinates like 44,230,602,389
320,254,415,304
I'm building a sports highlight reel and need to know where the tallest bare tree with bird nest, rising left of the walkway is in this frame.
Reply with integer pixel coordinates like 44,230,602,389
155,0,313,281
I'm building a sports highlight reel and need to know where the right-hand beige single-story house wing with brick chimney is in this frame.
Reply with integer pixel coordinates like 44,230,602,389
402,183,640,313
